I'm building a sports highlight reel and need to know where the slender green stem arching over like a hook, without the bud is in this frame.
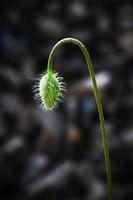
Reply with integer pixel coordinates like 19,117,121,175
48,38,113,200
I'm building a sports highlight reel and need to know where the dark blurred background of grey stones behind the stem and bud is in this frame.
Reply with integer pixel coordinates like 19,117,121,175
0,0,133,200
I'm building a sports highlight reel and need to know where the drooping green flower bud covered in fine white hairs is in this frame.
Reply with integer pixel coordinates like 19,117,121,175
36,72,65,110
